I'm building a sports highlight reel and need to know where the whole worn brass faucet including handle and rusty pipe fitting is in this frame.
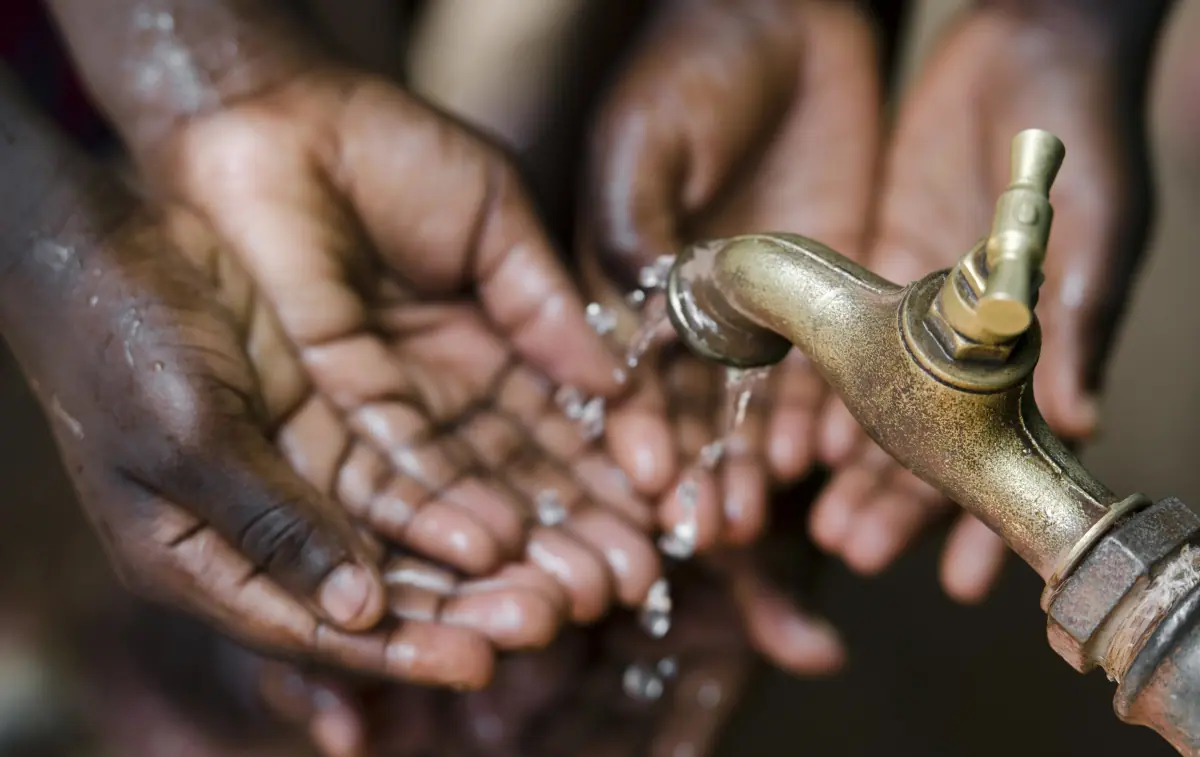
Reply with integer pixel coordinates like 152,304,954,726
667,130,1200,756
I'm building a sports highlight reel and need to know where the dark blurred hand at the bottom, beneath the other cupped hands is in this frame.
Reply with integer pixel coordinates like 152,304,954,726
262,566,787,757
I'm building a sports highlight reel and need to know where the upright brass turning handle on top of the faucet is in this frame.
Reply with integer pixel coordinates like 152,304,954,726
976,128,1066,338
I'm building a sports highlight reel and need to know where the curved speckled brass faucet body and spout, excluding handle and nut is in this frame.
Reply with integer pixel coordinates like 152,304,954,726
668,234,1120,581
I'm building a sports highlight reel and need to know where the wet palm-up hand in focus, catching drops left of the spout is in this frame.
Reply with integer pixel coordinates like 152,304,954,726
146,68,676,667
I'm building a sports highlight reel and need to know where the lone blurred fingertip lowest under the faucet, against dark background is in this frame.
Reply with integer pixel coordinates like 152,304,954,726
730,557,846,675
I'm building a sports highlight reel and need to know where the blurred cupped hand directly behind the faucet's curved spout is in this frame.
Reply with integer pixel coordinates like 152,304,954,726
581,0,880,563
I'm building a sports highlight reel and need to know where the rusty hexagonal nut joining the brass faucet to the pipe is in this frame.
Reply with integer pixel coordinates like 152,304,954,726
1046,498,1200,673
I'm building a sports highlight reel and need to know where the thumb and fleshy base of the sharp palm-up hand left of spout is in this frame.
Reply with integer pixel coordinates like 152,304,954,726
331,80,619,395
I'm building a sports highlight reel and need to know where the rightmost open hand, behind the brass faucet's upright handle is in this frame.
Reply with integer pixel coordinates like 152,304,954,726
811,7,1150,601
